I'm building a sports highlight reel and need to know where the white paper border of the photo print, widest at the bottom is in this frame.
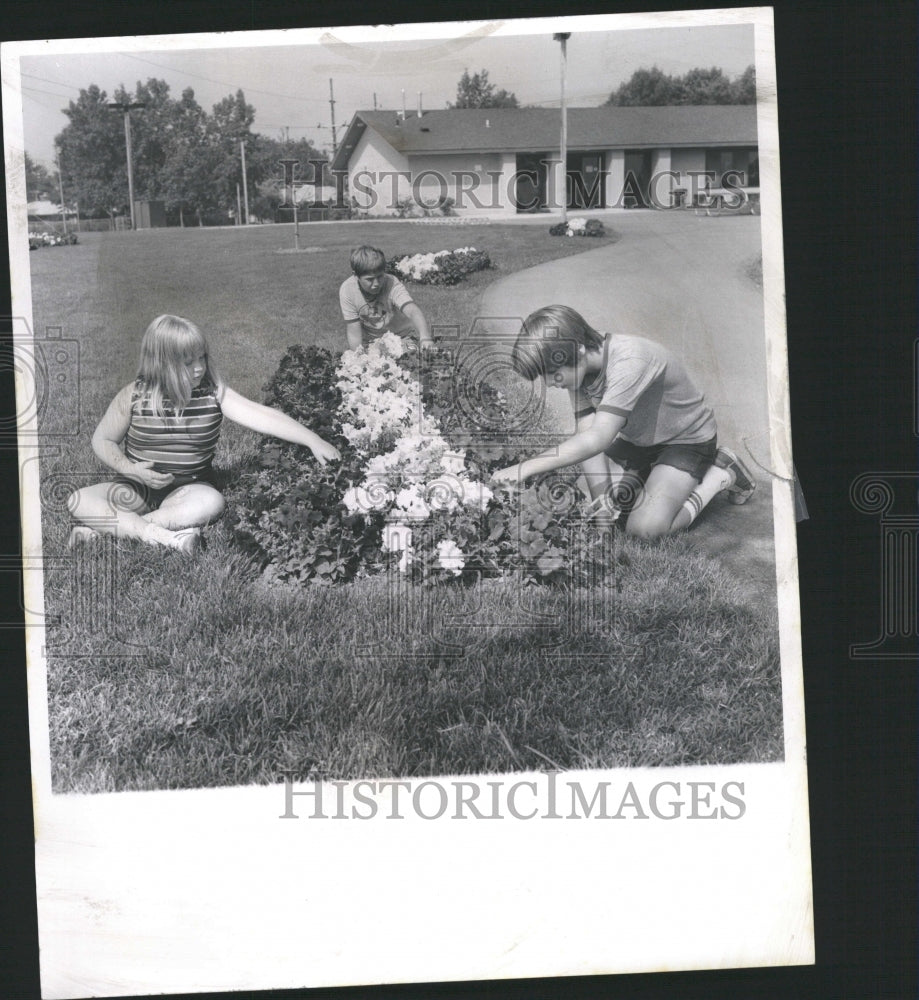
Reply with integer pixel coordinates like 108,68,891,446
0,7,814,998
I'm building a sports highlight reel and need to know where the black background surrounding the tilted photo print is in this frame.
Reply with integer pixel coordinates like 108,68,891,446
0,0,917,1000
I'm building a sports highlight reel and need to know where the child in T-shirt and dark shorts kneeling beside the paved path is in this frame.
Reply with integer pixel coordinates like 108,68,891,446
494,305,756,538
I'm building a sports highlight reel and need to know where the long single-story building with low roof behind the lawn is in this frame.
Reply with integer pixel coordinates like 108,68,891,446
332,104,759,215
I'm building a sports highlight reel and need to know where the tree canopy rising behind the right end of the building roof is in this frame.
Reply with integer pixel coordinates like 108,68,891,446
605,65,756,107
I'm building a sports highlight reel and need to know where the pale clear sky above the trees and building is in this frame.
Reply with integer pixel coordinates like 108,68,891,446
14,18,754,166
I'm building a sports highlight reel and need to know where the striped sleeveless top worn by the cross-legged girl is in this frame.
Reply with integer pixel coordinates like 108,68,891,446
124,379,223,485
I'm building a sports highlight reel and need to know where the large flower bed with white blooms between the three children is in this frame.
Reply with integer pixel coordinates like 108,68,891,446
228,333,613,584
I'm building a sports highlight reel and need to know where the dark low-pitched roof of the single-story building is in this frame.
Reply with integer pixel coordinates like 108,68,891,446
332,104,757,170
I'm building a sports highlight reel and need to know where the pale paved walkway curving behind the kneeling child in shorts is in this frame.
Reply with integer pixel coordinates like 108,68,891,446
479,211,775,599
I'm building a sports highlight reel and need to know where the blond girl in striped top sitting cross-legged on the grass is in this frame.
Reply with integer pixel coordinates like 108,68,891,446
68,316,341,554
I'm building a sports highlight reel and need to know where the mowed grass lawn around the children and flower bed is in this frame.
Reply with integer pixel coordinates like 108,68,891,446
30,223,782,791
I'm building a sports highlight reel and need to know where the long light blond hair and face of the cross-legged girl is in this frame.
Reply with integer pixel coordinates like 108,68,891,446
137,314,221,416
